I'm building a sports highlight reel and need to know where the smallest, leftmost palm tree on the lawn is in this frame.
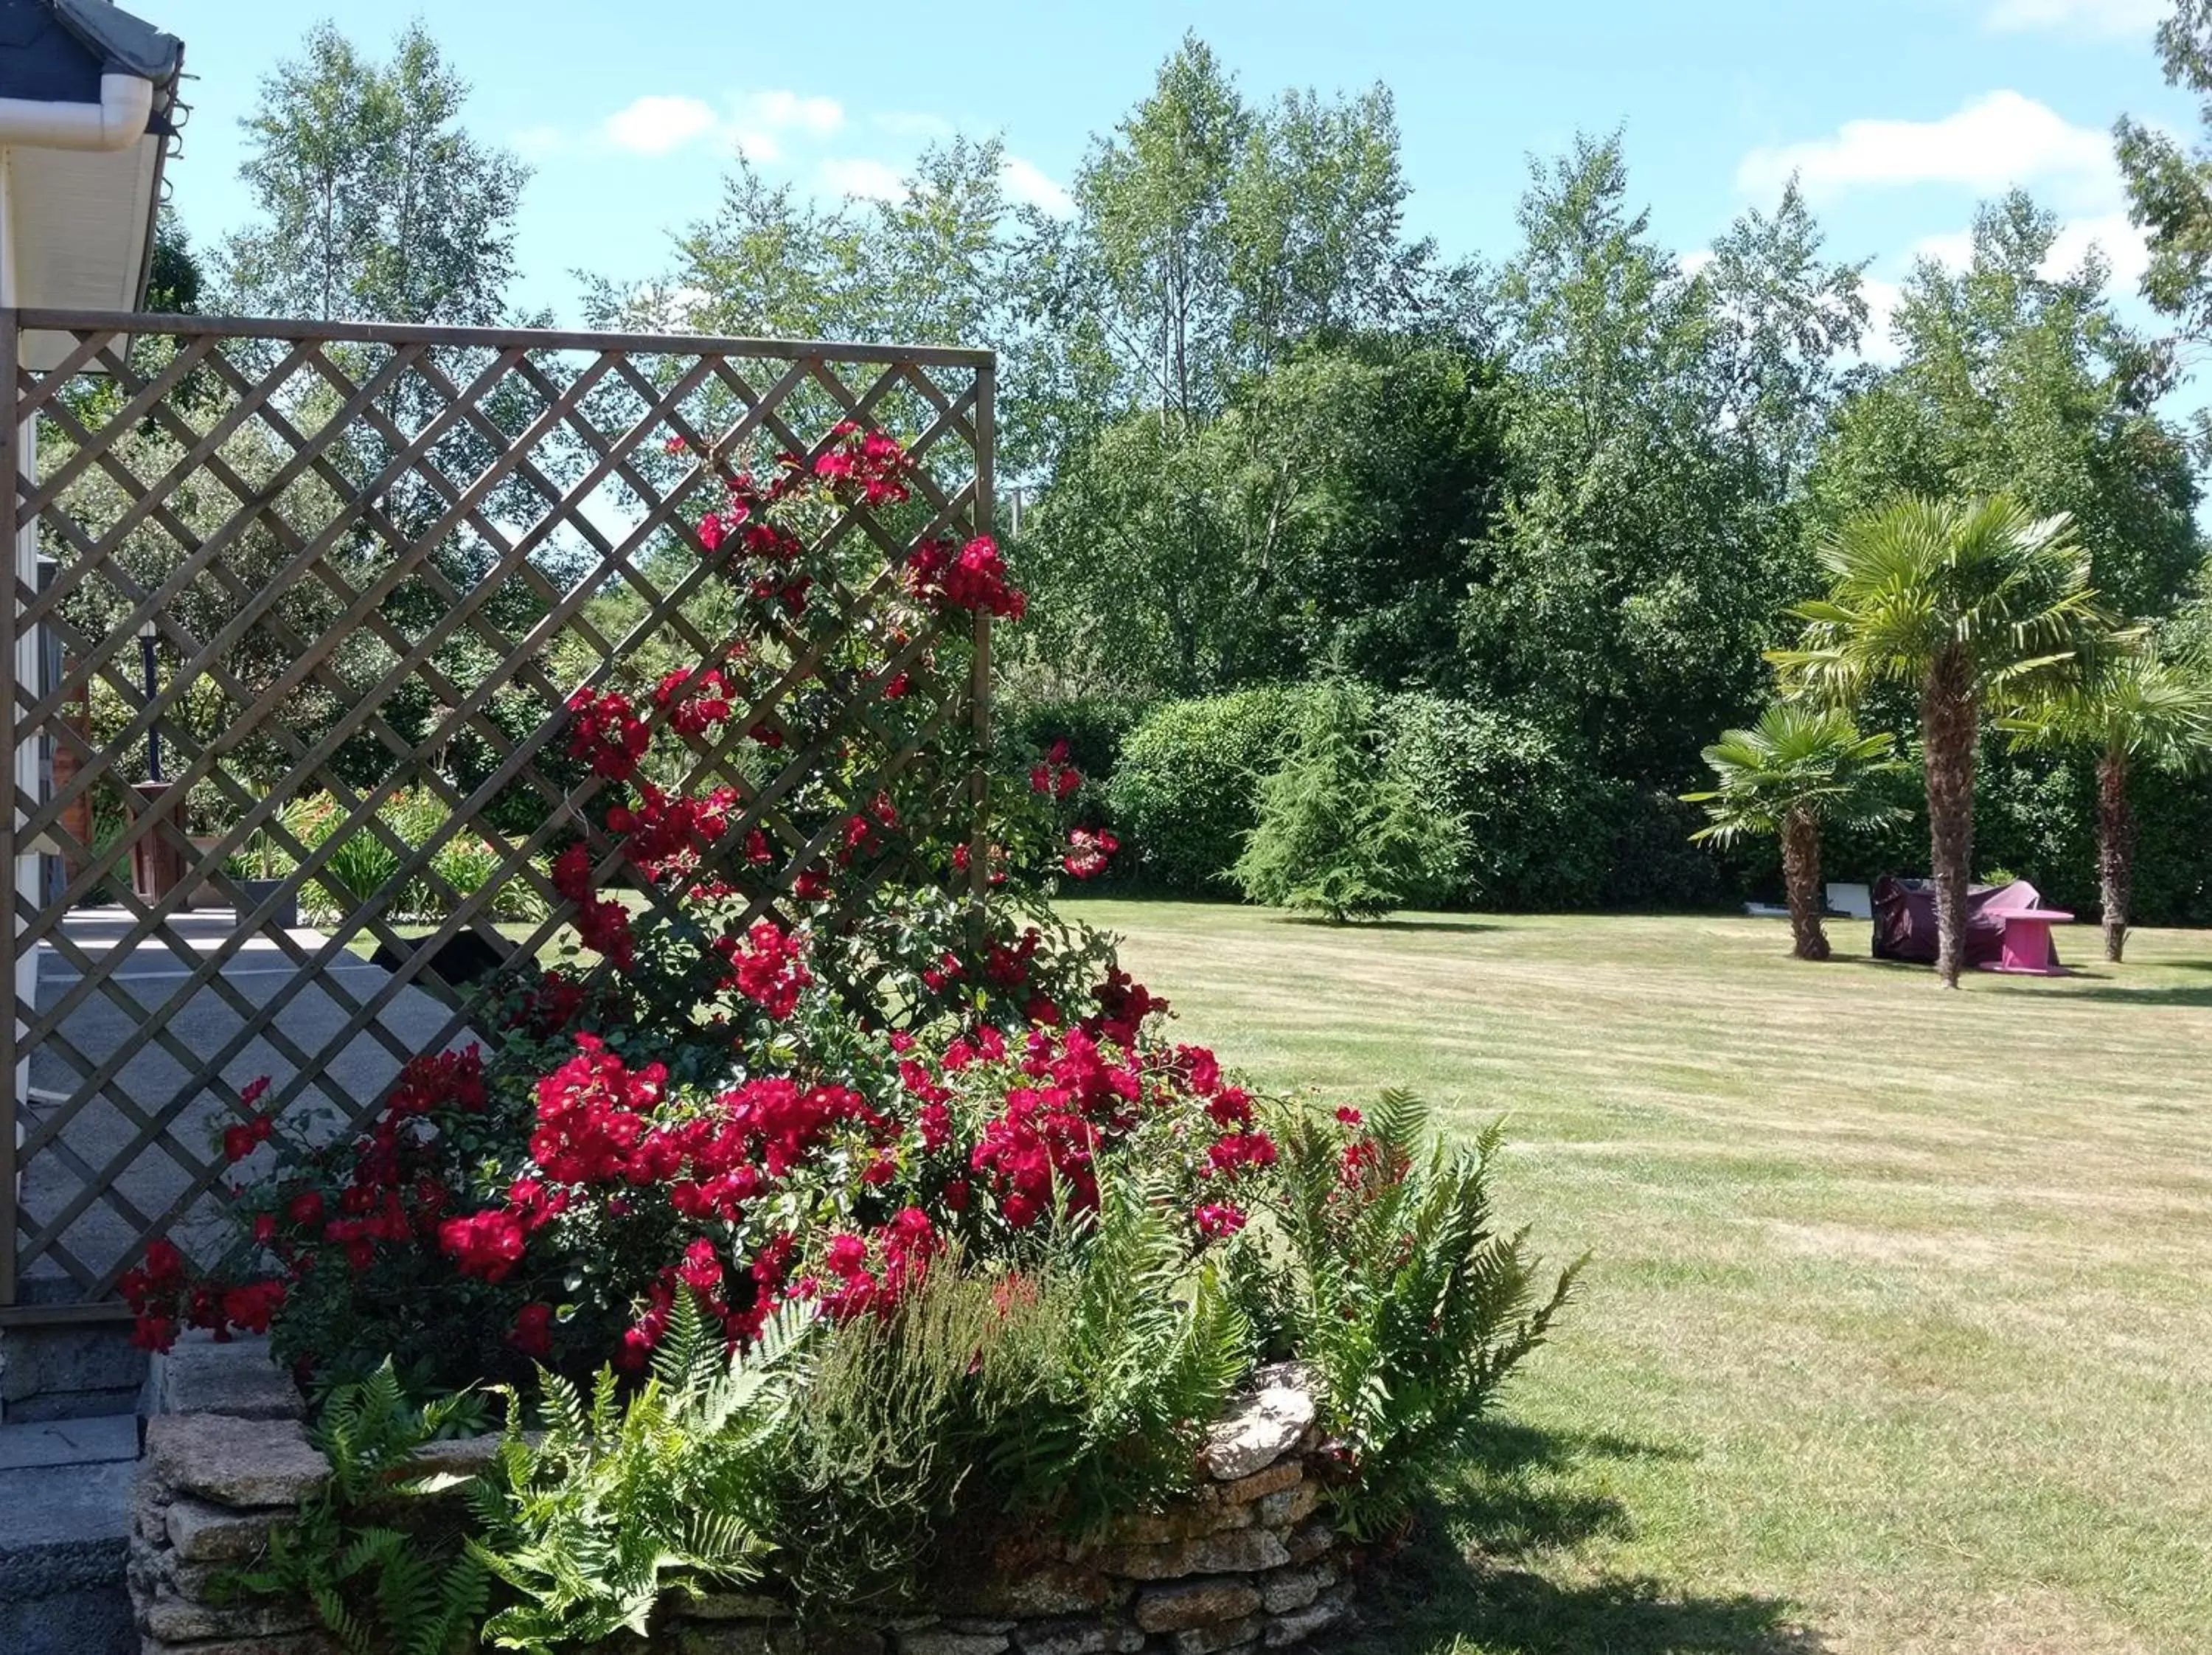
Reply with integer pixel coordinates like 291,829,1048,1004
1683,701,1898,960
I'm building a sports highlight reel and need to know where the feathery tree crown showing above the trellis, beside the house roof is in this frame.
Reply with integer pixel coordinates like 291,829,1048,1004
226,22,529,325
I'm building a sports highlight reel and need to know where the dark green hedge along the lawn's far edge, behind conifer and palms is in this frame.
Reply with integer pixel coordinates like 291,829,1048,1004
1097,684,2212,925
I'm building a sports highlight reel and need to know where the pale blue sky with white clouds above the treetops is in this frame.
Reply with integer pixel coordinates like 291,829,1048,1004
151,0,2194,352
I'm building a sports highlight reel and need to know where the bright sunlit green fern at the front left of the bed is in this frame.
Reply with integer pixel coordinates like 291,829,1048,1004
469,1292,810,1651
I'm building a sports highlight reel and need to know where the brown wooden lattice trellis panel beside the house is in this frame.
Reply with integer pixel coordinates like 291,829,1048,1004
0,312,993,1319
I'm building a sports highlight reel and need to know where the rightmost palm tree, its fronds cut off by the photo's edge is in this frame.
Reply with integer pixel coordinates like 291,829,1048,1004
2000,655,2212,965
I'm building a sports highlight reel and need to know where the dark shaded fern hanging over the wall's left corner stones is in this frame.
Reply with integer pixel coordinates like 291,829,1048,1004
234,1361,491,1655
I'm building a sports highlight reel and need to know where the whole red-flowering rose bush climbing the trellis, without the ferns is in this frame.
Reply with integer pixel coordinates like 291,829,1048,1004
124,425,1177,1383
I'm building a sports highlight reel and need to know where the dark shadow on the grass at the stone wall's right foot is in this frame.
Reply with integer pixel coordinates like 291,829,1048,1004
1354,1423,1827,1655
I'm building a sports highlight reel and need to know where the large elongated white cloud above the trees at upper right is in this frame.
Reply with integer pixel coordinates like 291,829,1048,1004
1736,91,2112,204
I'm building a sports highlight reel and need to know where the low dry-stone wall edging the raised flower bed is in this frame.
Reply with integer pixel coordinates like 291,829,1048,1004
131,1341,1356,1655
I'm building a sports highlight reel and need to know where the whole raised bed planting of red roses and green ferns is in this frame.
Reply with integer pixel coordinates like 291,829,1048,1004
126,427,1566,1655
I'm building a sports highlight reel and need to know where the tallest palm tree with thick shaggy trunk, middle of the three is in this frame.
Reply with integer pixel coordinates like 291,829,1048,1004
1770,493,2124,989
